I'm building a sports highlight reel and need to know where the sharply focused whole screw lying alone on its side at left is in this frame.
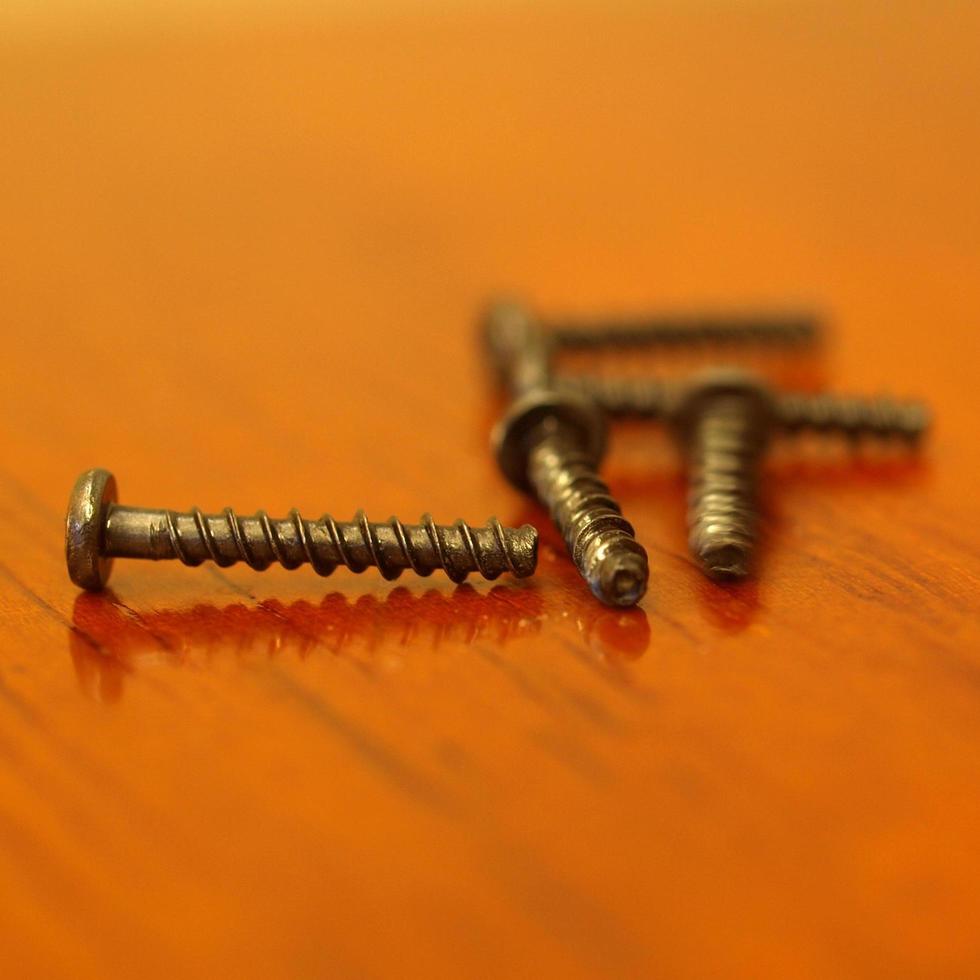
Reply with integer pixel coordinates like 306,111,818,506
65,470,538,591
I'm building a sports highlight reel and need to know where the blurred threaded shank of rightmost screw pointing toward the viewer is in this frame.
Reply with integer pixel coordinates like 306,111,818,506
688,397,764,580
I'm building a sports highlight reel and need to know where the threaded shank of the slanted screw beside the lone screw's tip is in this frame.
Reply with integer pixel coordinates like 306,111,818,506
528,434,649,606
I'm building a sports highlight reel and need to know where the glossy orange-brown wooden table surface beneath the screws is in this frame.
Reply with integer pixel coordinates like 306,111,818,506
0,2,980,978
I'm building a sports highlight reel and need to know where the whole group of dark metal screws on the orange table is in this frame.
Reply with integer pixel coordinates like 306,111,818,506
66,302,929,606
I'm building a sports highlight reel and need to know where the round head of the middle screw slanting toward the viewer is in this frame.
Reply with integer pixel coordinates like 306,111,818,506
490,391,606,493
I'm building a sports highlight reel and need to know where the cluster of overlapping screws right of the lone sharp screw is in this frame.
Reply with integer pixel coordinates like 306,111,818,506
482,301,929,605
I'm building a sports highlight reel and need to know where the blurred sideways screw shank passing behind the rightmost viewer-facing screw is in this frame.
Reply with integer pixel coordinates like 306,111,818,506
559,376,929,442
